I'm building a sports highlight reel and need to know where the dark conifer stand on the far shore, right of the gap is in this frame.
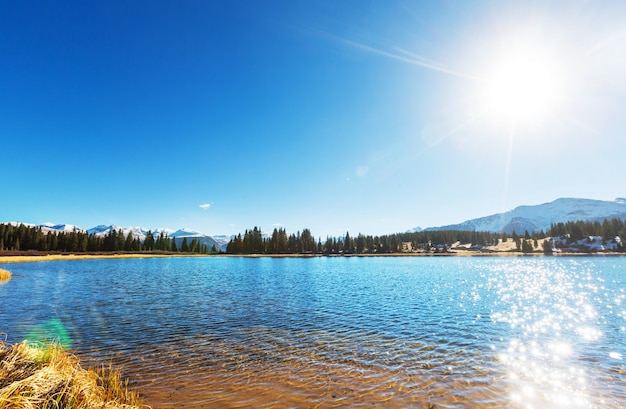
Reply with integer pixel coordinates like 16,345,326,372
226,219,626,254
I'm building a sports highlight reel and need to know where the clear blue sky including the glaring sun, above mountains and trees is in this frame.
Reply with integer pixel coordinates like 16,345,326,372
0,0,626,237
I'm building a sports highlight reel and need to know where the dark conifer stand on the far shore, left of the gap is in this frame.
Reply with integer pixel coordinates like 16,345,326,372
0,224,209,254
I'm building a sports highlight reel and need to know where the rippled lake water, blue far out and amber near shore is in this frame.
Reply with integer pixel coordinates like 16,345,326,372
0,257,626,408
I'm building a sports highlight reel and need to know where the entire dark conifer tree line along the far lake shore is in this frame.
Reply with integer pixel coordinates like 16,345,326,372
0,218,626,254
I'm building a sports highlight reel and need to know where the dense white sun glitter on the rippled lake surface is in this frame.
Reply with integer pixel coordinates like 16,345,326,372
491,260,604,408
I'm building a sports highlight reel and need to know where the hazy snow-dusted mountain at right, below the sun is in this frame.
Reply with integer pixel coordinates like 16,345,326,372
416,198,626,234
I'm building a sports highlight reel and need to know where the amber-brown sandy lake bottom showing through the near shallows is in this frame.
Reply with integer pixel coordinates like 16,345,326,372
79,329,508,408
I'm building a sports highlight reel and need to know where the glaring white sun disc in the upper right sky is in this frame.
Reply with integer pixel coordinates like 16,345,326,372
483,51,562,122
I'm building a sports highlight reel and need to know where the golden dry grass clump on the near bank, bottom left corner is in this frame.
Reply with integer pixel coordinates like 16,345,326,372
0,341,146,409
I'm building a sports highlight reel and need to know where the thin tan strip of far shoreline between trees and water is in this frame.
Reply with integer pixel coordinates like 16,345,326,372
0,250,626,264
